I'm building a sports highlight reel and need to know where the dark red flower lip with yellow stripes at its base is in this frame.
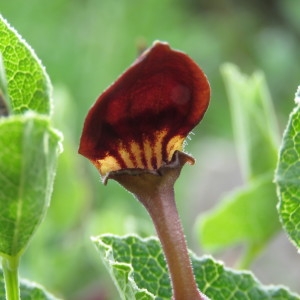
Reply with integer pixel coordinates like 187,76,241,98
79,42,210,176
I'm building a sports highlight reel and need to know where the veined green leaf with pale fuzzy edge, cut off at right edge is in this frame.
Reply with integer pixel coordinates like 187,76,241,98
275,88,300,249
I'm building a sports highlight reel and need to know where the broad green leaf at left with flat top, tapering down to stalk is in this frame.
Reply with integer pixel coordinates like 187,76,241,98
0,113,61,256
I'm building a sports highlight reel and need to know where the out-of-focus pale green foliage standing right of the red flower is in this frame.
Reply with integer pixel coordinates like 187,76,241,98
197,64,281,267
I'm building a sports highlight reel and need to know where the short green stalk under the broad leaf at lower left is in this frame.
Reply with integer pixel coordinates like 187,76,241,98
2,256,21,300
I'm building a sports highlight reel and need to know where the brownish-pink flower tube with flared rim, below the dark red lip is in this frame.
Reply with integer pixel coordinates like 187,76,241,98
109,151,208,300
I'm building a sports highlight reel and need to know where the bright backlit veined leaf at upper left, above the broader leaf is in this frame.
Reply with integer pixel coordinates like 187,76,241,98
0,15,52,114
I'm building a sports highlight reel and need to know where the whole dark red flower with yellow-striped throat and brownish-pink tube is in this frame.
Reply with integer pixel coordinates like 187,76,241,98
79,42,210,300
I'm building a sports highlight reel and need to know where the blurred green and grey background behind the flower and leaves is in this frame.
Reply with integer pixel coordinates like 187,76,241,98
0,0,300,300
